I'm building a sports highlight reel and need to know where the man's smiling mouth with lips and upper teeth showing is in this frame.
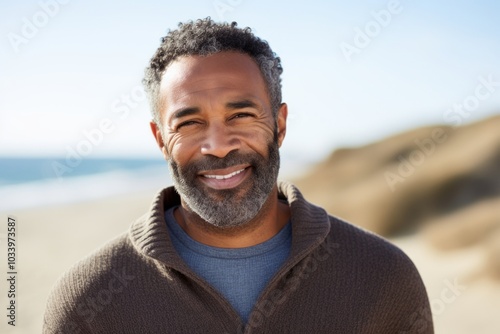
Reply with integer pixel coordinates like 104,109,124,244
198,165,251,190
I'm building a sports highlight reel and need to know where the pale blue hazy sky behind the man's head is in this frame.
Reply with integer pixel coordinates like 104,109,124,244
0,0,500,160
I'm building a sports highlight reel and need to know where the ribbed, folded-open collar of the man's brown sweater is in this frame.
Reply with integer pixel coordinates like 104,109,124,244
129,182,330,269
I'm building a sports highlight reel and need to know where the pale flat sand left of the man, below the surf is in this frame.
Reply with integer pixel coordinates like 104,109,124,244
0,189,156,334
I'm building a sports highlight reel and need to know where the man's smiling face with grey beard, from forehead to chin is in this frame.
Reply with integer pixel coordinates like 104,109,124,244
151,52,287,228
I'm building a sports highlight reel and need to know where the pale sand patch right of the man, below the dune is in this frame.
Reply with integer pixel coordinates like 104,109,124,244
392,235,500,334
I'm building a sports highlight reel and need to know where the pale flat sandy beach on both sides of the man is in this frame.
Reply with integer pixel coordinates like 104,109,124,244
0,189,500,334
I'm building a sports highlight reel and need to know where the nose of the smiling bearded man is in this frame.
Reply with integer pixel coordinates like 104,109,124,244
201,124,241,158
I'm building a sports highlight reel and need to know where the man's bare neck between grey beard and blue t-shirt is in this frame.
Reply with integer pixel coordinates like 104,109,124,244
174,187,290,248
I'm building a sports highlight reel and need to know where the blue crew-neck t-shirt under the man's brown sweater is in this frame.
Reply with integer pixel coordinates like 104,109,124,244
165,208,292,322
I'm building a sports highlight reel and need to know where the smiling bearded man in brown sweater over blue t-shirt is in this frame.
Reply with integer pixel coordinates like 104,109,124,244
44,19,433,333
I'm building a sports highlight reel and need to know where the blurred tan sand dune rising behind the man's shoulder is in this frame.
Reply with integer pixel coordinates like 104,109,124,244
295,116,500,235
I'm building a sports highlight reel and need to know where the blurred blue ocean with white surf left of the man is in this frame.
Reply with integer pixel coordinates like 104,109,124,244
0,157,172,213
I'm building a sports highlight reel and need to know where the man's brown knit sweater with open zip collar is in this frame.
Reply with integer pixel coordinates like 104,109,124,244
43,183,433,334
